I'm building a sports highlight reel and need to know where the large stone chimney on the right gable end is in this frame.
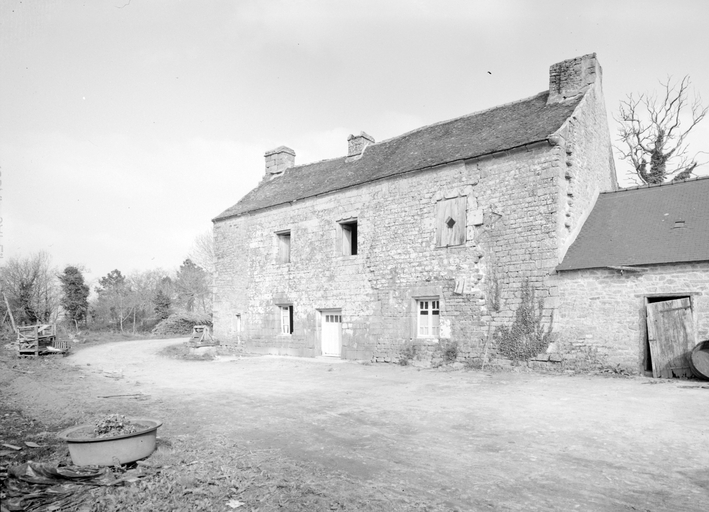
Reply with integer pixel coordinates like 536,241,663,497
547,53,602,105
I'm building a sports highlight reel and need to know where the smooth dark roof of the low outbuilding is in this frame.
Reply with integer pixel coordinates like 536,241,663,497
557,177,709,270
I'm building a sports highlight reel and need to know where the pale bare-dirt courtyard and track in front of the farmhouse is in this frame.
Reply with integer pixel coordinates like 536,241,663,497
3,340,709,511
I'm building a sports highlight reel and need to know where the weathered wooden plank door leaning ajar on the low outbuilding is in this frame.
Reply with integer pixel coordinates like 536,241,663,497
647,298,695,379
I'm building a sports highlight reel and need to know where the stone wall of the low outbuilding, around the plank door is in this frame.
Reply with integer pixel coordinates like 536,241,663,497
553,262,709,372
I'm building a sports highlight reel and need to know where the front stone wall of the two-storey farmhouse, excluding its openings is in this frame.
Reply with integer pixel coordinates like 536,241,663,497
214,139,563,360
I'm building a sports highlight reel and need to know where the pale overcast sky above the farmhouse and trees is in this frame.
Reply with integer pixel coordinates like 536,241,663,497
0,0,709,286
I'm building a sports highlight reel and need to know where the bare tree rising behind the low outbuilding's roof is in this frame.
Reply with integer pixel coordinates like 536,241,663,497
616,76,709,185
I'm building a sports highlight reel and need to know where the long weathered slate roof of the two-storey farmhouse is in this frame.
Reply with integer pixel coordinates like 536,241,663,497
214,91,582,221
